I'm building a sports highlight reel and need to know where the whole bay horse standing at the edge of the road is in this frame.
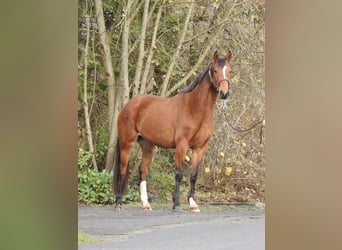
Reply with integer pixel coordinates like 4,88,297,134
113,51,232,212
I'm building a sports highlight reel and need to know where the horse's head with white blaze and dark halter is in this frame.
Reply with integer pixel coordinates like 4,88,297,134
209,51,232,99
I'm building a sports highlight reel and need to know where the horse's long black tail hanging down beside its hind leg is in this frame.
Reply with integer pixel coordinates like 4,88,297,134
113,138,129,195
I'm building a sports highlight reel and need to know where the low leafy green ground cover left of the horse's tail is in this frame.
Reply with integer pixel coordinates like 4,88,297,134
78,169,114,204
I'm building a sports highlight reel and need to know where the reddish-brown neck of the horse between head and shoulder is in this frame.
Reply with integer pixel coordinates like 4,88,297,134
189,75,218,118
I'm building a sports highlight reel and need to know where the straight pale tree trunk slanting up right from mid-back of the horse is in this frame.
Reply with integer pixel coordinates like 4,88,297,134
160,2,195,96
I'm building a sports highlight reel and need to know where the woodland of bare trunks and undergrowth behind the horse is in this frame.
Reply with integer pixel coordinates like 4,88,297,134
78,0,265,203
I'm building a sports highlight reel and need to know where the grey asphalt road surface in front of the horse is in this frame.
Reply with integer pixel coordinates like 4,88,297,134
78,205,265,250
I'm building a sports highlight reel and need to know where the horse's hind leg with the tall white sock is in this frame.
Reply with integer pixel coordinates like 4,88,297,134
138,137,154,210
